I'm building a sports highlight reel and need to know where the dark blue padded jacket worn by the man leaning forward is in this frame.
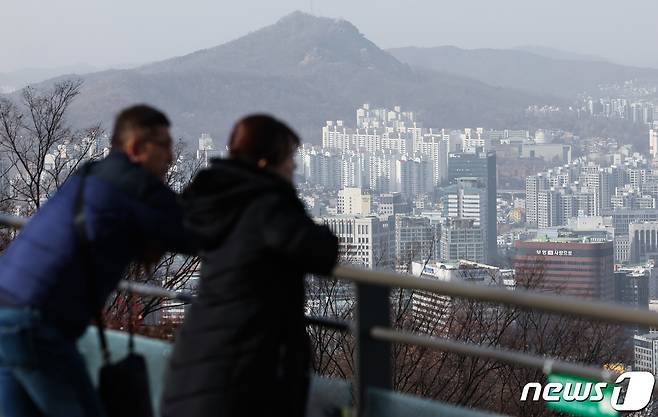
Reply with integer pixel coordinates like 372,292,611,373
0,151,192,338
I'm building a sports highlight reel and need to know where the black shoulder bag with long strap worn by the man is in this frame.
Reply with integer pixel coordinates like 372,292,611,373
74,163,153,417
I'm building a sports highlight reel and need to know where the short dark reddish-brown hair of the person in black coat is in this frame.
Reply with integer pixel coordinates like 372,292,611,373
228,114,300,166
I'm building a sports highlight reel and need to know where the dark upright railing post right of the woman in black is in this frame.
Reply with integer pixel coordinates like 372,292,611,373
354,284,393,417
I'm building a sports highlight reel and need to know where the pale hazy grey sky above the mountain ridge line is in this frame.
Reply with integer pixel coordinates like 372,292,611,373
0,0,658,71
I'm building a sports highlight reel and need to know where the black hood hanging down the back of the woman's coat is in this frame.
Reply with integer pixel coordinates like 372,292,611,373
182,159,297,248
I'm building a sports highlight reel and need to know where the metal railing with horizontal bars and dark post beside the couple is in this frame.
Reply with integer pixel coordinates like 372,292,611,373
6,214,658,416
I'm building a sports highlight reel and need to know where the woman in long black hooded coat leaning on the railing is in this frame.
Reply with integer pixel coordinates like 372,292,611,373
162,115,338,417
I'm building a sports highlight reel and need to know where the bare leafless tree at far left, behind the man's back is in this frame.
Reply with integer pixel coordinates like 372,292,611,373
0,80,103,215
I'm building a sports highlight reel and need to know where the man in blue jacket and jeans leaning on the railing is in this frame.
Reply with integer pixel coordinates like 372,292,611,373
0,105,189,417
